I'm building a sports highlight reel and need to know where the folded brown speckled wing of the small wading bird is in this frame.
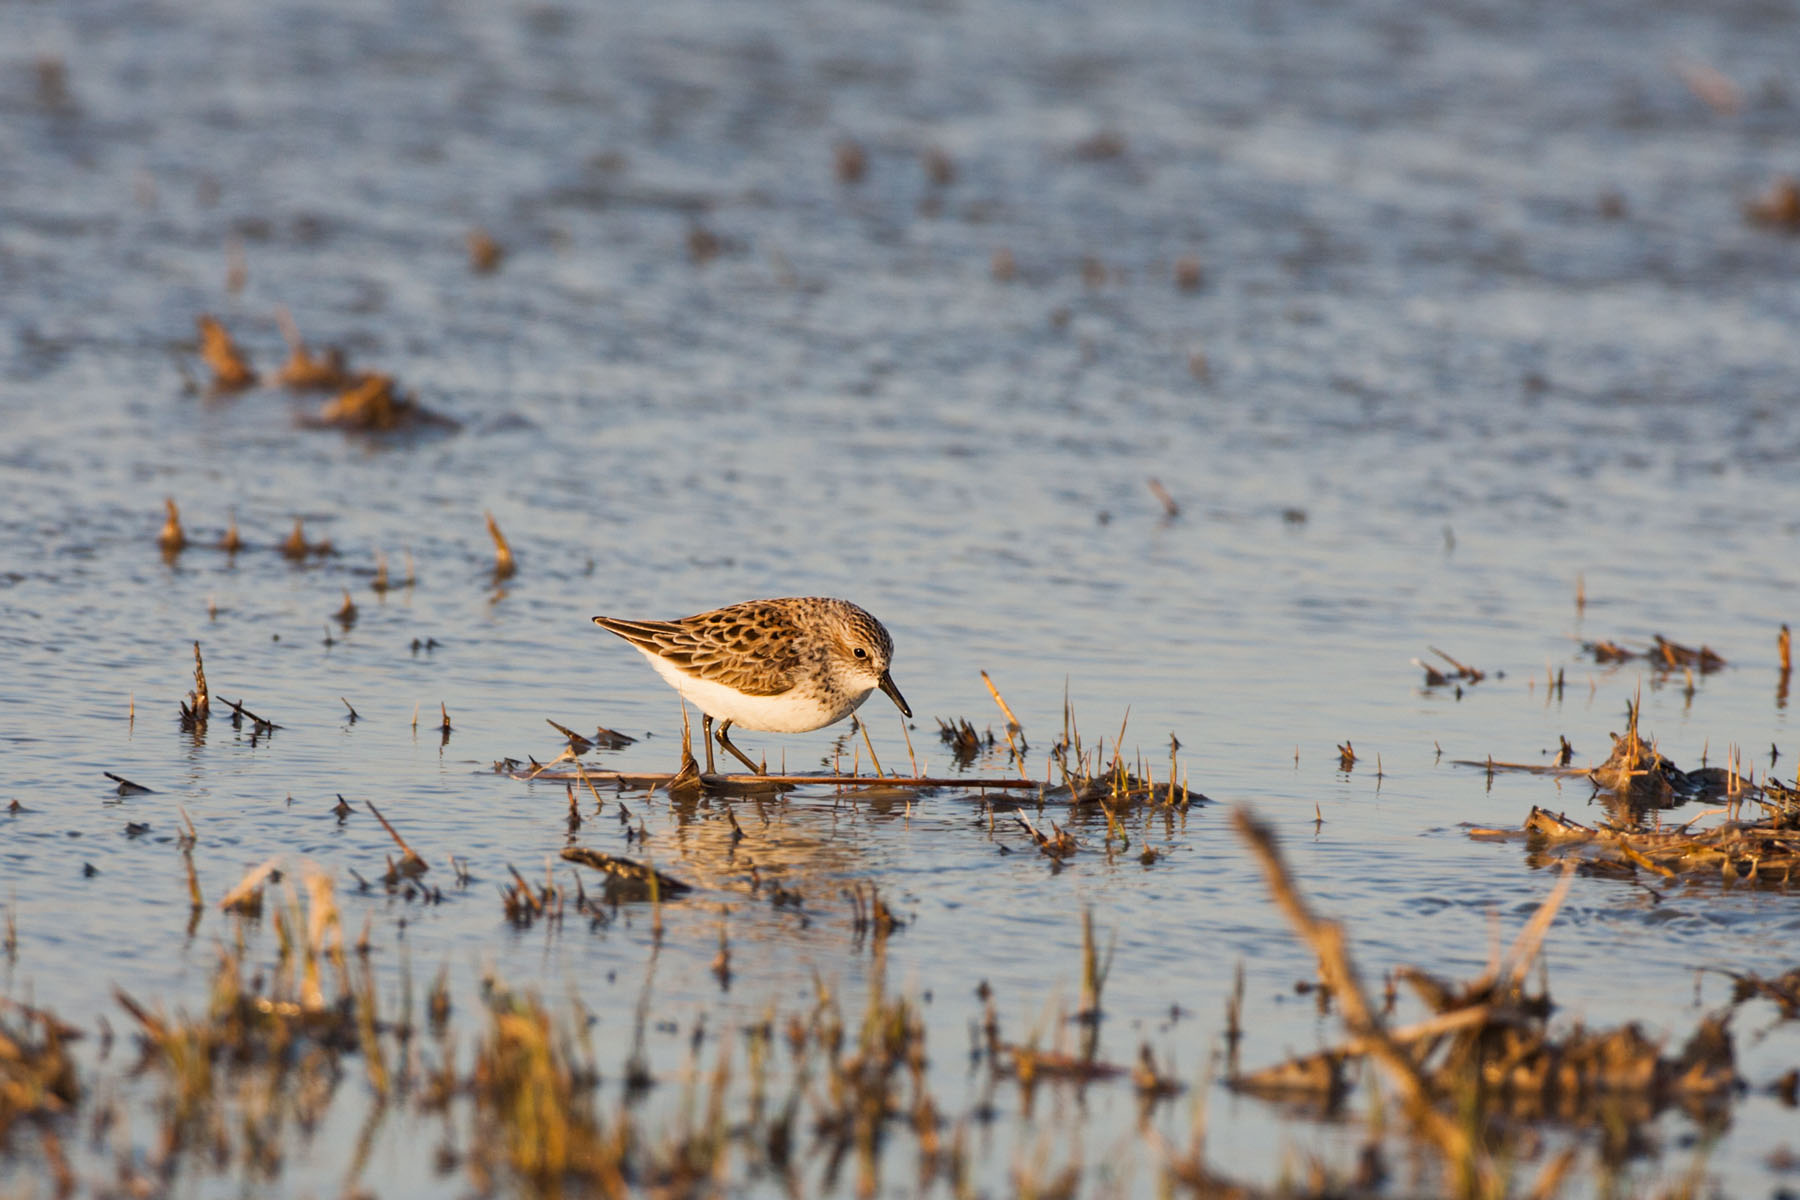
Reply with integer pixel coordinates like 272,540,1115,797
594,603,801,696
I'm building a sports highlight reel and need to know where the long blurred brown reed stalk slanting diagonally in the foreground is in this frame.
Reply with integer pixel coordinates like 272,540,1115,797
1231,808,1497,1196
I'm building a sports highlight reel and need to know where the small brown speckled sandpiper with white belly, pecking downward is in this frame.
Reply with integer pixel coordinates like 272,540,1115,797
594,596,913,774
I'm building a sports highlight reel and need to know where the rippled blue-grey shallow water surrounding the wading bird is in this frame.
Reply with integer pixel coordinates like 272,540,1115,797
0,0,1800,1195
